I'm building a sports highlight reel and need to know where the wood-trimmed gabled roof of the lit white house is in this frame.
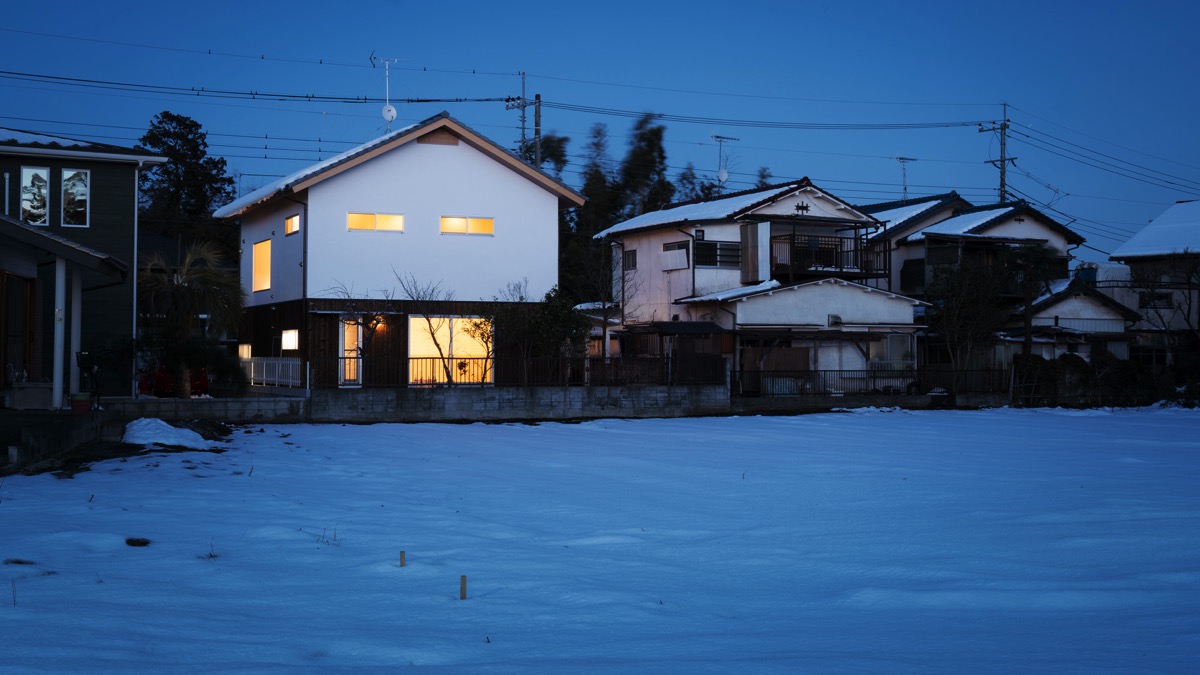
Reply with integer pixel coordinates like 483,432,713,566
220,112,583,219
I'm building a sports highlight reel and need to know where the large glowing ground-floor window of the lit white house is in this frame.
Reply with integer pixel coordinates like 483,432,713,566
408,316,493,384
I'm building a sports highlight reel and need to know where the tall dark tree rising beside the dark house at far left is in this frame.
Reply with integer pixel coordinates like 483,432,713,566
137,110,236,257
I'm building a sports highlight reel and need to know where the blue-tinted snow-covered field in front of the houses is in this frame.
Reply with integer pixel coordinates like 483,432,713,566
0,410,1200,673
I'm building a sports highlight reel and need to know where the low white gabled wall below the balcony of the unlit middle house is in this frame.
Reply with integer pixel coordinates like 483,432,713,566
733,283,913,325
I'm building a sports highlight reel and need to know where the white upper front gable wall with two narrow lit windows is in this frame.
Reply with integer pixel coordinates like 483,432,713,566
307,142,558,300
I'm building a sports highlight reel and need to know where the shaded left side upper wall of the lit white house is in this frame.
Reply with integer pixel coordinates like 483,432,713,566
240,201,306,306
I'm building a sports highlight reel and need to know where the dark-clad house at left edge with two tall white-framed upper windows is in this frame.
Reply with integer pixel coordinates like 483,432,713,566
0,127,166,407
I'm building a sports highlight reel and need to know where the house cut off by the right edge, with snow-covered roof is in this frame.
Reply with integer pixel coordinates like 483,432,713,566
1100,201,1200,359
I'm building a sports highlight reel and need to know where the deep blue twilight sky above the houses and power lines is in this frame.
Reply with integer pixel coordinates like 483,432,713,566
0,0,1200,259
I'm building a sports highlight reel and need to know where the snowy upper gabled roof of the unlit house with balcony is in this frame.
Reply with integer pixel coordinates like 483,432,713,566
595,178,874,239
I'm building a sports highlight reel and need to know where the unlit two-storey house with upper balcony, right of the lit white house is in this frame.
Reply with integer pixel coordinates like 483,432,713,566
596,179,918,393
